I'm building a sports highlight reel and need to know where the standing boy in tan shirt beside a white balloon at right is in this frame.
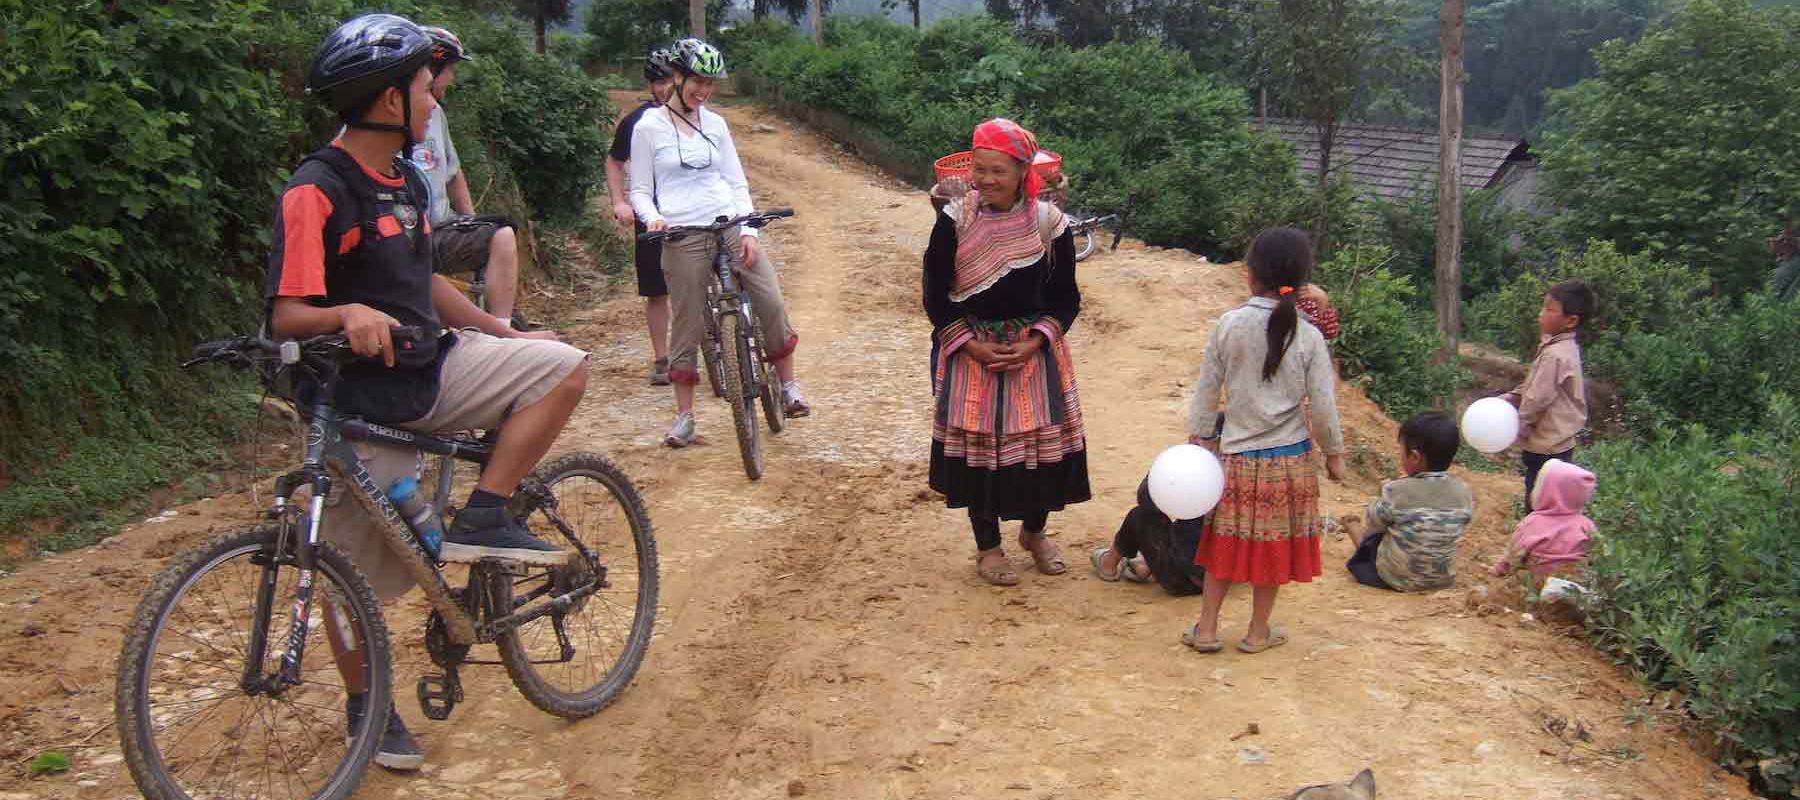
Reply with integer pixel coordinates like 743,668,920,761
1505,281,1598,497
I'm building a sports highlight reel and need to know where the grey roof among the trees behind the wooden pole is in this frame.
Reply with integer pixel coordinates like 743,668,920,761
1251,117,1532,198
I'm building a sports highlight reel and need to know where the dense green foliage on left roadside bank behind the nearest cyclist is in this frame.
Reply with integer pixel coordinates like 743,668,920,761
0,0,610,544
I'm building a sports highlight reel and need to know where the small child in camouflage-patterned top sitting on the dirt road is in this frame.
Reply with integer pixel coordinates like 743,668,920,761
1345,411,1474,591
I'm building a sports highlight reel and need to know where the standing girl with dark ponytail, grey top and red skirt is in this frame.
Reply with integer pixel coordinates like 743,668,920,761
1183,227,1345,652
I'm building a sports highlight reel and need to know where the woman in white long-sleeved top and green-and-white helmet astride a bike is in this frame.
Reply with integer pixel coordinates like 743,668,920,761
630,38,812,447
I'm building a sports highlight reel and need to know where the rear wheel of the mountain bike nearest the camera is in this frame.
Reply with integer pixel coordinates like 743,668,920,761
495,452,657,719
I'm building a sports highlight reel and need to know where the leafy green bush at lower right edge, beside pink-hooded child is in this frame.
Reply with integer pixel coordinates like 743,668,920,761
1586,396,1800,762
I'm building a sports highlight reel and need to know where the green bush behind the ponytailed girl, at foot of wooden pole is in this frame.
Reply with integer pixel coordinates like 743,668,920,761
1316,245,1469,420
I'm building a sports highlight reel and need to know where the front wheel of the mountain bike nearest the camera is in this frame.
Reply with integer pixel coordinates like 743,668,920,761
113,521,392,800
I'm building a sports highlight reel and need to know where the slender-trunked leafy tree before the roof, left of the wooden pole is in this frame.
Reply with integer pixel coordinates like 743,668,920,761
1242,0,1424,252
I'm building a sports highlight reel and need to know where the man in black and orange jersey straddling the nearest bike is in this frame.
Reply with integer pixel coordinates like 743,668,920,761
265,14,587,769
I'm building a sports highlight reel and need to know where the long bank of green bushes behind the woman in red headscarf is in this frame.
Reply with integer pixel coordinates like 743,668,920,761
727,18,1300,254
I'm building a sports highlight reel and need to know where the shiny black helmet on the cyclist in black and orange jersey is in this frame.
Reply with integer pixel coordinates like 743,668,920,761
306,14,432,131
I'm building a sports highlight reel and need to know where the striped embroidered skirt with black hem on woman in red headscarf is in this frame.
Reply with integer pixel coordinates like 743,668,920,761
931,321,1091,519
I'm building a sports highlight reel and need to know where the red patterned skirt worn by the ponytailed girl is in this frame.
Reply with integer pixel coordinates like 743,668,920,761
1193,441,1321,586
